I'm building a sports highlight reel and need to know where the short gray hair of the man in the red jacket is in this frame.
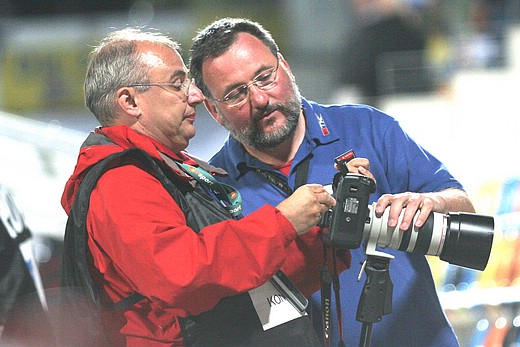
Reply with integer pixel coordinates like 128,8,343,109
84,28,180,126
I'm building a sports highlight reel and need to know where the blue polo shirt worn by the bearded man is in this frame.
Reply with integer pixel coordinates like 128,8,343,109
210,99,462,347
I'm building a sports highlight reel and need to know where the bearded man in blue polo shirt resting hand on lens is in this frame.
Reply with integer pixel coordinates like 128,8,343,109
190,18,474,347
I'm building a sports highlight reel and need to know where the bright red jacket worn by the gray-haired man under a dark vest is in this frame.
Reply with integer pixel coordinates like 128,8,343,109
62,126,346,346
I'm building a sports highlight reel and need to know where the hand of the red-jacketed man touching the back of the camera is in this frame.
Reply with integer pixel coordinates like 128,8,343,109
276,184,336,235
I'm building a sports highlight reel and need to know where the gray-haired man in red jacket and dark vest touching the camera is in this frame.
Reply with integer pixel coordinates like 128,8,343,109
62,28,342,346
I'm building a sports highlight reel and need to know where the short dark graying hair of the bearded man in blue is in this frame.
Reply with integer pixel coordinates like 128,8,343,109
190,18,278,97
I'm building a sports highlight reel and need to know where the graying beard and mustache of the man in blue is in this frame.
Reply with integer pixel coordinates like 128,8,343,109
224,83,301,150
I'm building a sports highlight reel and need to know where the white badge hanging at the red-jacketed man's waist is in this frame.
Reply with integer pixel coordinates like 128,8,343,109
249,281,307,330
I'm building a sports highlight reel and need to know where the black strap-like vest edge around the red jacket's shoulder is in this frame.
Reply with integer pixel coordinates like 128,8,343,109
61,148,190,311
